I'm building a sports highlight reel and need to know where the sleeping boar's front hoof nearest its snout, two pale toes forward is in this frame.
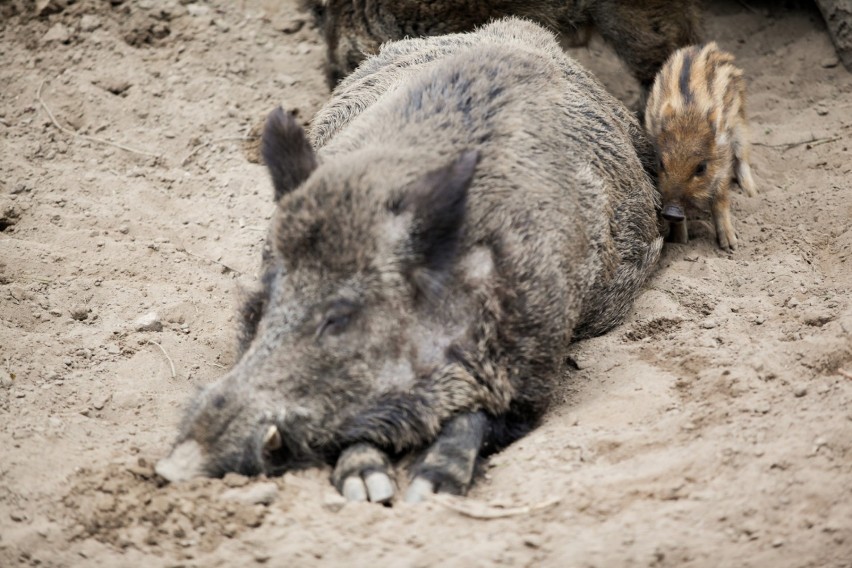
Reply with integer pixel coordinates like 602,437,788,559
331,443,395,503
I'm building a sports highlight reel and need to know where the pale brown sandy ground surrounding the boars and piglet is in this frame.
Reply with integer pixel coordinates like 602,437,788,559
0,0,852,567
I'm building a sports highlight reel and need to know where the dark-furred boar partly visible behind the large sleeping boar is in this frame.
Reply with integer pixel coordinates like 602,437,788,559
302,0,701,88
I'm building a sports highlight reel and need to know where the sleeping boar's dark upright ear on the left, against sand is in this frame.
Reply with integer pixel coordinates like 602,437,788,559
260,107,317,201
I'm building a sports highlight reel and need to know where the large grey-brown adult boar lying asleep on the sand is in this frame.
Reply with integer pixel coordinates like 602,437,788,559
157,19,661,501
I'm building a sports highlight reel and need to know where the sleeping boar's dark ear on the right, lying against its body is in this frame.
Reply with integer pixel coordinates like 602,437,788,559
394,150,479,288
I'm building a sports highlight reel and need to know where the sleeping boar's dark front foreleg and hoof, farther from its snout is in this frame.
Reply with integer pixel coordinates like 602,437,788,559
405,412,488,503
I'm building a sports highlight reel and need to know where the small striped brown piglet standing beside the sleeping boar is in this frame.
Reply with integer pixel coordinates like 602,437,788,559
645,42,757,250
